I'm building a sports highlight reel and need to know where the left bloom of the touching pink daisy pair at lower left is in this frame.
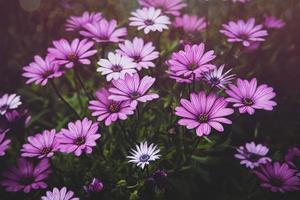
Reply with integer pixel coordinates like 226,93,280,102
21,129,59,158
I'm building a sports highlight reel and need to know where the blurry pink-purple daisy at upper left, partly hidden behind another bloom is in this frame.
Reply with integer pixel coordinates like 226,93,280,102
66,12,103,31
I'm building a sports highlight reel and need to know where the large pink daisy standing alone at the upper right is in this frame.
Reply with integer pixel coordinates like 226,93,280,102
220,18,268,47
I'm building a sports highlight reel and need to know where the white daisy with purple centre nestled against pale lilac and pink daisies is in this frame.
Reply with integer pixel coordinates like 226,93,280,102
97,52,137,81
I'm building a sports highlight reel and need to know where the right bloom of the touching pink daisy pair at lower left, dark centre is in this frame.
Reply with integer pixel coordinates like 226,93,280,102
56,118,101,156
